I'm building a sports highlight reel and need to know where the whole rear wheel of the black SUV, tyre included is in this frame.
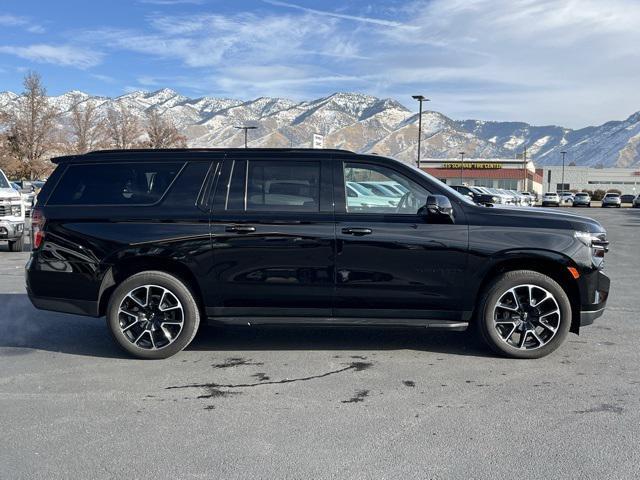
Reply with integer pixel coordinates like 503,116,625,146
107,271,200,359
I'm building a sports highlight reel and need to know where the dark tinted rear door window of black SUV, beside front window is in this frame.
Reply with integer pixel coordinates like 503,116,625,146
247,161,320,212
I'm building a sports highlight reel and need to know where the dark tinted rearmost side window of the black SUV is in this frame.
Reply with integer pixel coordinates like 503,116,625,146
47,162,184,205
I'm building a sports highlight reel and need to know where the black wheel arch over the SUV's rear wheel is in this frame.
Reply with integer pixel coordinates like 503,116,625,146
98,255,205,316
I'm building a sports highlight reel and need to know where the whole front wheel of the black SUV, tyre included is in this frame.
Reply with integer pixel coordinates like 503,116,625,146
477,270,571,358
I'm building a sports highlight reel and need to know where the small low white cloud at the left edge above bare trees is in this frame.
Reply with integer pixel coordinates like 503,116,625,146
0,44,102,69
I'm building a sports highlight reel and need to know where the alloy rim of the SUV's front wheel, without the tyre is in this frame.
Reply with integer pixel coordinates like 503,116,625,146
493,284,561,350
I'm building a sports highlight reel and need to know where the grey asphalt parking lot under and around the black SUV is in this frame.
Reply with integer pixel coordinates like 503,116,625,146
0,209,640,479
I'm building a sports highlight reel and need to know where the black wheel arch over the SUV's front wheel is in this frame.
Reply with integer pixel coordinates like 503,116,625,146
472,250,580,334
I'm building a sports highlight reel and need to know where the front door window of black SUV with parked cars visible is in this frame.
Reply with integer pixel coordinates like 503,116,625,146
344,163,429,215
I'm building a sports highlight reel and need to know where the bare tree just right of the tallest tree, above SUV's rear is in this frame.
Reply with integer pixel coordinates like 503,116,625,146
67,100,108,154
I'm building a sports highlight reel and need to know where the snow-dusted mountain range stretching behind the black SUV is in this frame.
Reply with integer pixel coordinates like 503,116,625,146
0,88,640,167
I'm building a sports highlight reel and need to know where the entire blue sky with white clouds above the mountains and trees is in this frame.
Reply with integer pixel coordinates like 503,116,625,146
0,0,640,127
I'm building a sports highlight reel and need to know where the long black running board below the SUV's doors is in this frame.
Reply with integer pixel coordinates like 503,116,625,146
207,316,469,332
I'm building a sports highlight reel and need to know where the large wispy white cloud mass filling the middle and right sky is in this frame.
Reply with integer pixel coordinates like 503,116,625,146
74,0,640,127
